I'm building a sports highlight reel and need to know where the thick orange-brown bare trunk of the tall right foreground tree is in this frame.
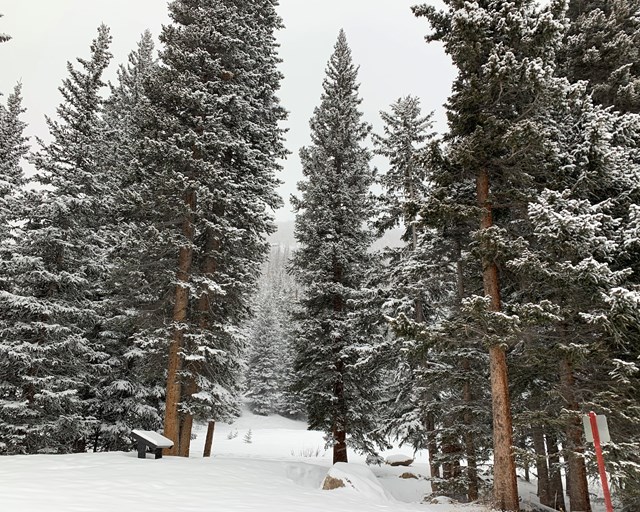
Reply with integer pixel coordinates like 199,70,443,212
476,170,520,511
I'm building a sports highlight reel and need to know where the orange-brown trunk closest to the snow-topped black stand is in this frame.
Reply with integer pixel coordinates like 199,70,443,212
164,189,196,455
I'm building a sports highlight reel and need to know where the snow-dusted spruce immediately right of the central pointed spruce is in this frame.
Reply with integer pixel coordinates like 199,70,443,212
374,96,444,485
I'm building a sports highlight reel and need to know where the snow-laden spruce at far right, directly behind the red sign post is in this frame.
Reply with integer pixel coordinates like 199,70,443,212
510,89,640,508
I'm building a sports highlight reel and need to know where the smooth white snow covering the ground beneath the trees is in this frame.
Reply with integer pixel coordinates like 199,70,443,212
0,413,490,512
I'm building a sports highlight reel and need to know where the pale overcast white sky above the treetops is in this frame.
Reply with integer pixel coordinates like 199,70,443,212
0,0,454,220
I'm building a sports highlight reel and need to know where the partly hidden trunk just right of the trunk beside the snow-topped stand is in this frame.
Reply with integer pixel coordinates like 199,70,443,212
180,229,220,457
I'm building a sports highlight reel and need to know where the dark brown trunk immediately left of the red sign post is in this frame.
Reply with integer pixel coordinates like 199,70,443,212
560,357,591,512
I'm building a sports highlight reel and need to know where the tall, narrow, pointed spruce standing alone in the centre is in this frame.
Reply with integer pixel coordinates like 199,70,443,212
292,31,384,462
